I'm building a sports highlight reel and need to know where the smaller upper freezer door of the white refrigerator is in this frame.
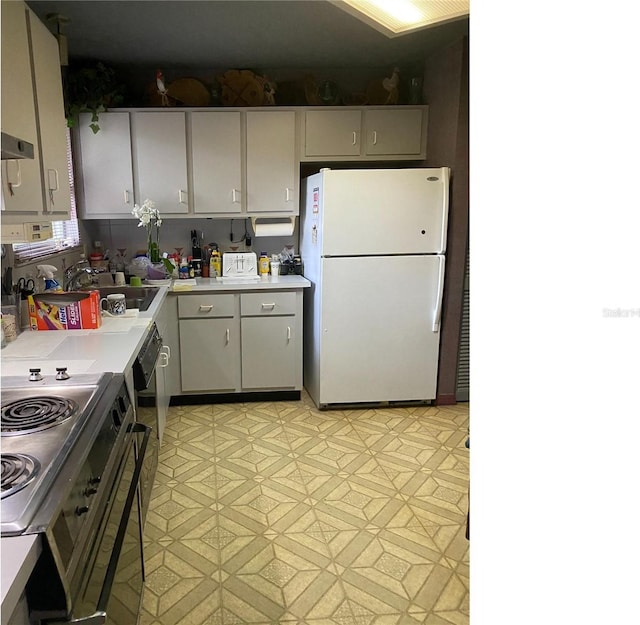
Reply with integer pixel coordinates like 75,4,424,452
320,167,449,256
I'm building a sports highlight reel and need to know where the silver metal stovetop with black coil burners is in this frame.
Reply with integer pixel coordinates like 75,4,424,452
0,373,113,536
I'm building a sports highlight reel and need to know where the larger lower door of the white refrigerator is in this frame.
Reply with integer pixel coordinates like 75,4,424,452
314,256,444,405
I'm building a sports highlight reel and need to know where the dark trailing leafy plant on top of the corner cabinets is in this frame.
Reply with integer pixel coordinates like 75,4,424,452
64,62,124,133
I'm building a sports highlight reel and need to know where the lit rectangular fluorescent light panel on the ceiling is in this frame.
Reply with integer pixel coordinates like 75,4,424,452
333,0,469,37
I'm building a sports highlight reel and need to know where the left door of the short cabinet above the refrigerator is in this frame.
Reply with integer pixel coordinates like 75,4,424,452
304,111,362,156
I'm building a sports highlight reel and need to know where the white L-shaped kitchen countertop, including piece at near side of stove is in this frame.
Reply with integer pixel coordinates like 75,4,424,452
0,275,311,625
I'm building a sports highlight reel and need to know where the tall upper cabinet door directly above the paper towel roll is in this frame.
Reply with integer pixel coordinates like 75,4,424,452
247,111,300,215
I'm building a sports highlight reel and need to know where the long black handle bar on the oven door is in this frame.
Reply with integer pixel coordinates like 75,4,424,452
47,423,151,625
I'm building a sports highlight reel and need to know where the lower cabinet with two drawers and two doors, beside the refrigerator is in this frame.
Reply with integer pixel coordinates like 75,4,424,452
172,290,302,394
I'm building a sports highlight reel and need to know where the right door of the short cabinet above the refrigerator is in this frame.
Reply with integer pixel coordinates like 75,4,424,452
364,109,423,157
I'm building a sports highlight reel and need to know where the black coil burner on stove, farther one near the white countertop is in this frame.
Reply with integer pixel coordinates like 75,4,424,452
1,395,78,436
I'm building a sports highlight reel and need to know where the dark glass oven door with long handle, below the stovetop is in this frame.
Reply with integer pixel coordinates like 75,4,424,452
54,423,151,625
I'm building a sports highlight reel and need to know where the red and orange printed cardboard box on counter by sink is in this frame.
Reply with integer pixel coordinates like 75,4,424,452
28,291,102,330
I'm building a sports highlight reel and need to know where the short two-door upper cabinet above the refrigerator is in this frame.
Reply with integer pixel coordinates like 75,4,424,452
300,106,428,162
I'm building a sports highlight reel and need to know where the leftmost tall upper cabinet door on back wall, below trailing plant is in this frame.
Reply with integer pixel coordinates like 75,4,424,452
78,113,134,218
